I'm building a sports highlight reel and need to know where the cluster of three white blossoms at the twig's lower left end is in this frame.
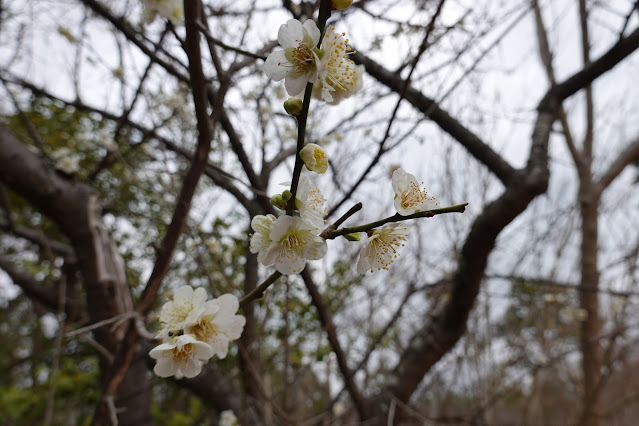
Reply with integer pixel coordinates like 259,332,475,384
149,285,246,379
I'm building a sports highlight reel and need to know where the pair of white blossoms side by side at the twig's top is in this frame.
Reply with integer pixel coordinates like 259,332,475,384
264,19,364,104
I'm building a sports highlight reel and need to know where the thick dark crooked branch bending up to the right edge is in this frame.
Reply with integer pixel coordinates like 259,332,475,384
376,20,639,416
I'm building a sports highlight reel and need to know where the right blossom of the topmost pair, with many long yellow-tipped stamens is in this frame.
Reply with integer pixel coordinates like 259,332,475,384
313,27,364,104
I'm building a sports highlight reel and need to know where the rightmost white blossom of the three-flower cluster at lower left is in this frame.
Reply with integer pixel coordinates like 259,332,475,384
185,294,246,359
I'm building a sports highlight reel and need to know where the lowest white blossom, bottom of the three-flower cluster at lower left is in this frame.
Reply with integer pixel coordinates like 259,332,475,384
149,334,214,379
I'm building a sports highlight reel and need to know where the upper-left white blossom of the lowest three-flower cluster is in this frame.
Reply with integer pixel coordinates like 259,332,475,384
160,285,207,336
